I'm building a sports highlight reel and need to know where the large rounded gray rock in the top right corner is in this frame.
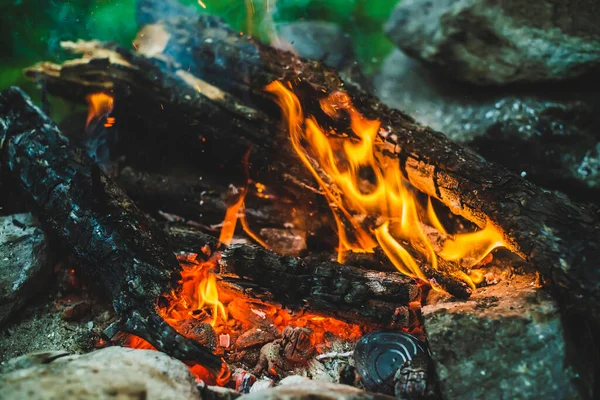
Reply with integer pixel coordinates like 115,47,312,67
385,0,600,85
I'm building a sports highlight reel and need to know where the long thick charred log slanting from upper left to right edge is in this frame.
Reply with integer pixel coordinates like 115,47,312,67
27,1,600,320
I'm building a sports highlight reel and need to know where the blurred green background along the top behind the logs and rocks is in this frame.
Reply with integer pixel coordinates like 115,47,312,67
0,0,398,117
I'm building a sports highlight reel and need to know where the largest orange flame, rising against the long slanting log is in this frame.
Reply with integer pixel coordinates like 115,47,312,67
266,81,504,289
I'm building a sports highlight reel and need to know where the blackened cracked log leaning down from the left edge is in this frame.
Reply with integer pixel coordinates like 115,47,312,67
0,87,222,372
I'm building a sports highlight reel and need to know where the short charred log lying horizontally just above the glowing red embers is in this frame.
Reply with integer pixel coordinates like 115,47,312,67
166,224,421,327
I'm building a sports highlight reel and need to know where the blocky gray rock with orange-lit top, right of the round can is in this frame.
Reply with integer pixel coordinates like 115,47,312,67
423,275,580,399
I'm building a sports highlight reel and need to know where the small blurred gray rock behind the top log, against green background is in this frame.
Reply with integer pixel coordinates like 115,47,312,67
277,21,354,69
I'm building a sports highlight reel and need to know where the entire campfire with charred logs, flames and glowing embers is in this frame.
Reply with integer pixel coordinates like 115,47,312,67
0,1,600,398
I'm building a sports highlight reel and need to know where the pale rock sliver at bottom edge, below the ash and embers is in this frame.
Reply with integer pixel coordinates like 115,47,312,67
239,380,394,400
